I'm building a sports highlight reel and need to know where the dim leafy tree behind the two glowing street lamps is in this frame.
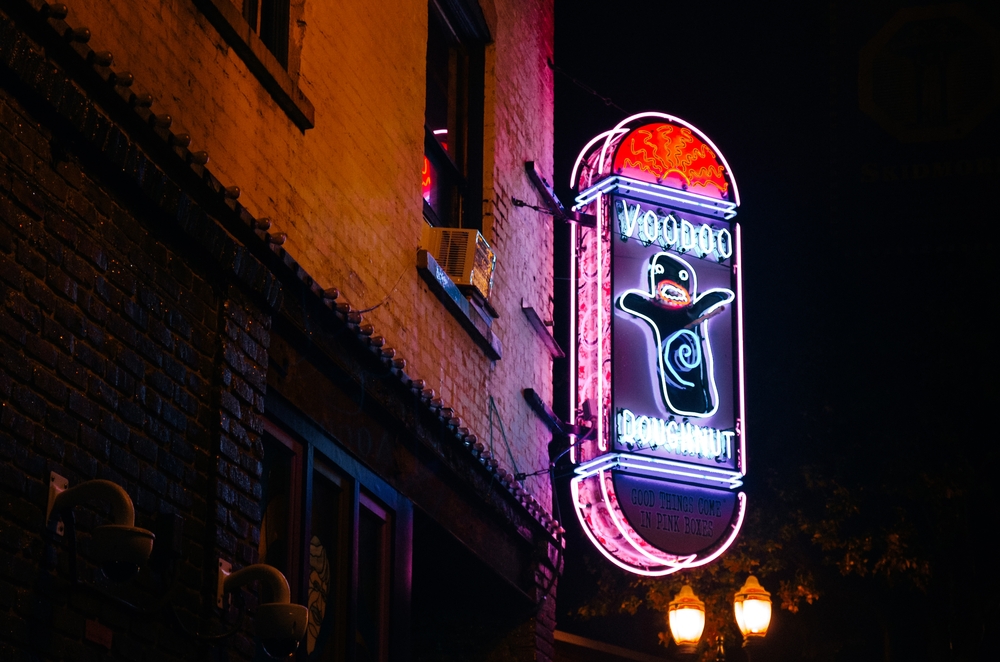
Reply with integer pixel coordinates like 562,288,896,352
571,429,990,660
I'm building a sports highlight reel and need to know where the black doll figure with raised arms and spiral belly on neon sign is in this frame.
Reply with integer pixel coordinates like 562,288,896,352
617,253,735,418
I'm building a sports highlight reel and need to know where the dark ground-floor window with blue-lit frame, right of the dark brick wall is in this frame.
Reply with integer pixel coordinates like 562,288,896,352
257,423,410,662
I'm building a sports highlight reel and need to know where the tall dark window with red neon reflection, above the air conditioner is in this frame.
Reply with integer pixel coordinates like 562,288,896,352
421,0,485,229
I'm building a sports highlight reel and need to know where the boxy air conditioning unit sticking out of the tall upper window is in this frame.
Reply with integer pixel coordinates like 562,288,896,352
421,226,497,299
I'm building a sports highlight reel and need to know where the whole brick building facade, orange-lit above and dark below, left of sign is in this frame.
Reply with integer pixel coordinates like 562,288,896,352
0,0,562,660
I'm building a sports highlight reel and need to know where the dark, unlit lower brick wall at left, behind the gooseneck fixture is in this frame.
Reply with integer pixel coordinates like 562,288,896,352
0,16,275,660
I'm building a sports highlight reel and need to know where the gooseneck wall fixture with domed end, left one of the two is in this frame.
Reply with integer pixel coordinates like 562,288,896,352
45,472,154,582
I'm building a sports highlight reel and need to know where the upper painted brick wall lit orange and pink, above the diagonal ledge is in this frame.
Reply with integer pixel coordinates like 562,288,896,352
60,0,553,503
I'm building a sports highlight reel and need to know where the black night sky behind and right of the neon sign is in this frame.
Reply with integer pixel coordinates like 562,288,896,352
551,0,1000,659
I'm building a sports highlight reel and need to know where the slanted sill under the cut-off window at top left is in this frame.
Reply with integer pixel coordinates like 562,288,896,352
189,0,316,131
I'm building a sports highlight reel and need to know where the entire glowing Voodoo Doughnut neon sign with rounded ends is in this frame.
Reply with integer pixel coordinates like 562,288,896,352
570,113,746,575
